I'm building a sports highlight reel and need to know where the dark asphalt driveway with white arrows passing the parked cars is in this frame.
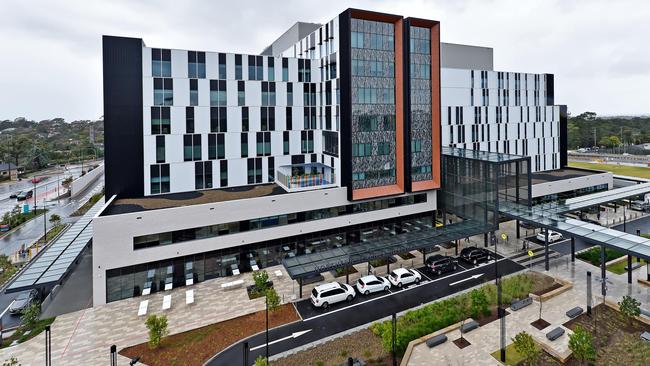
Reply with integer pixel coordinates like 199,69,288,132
207,259,524,366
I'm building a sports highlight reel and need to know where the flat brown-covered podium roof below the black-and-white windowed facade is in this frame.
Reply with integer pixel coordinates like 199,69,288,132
104,184,287,216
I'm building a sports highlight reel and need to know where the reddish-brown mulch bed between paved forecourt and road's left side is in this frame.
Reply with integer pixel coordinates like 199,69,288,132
120,304,300,366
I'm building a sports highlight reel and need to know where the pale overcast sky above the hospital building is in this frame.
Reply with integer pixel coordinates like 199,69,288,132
0,0,650,121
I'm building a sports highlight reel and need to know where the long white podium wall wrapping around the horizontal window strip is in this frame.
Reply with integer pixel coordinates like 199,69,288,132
93,188,436,305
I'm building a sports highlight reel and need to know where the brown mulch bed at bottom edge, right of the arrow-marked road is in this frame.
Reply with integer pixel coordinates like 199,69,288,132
271,329,390,366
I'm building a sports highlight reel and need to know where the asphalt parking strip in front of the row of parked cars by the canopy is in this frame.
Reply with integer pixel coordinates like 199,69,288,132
295,255,503,320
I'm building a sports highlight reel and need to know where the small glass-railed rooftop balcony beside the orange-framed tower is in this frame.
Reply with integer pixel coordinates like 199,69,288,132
275,163,336,192
